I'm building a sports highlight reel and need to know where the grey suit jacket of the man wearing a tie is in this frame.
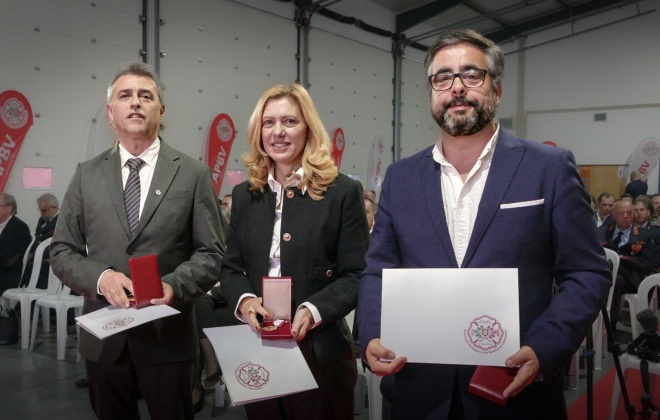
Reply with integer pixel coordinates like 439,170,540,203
51,141,224,364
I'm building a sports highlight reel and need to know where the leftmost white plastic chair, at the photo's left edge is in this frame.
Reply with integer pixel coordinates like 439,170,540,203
2,238,58,349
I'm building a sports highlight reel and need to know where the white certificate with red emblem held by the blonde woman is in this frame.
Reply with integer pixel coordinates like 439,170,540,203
204,324,318,405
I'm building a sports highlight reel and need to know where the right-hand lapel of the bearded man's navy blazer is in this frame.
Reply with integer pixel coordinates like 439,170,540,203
462,133,525,267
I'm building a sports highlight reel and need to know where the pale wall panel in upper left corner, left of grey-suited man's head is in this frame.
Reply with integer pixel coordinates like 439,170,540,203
0,0,142,215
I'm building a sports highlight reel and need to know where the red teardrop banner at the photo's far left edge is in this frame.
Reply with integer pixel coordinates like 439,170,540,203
0,90,33,191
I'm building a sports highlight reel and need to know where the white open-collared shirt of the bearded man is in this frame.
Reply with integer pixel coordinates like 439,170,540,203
433,124,500,267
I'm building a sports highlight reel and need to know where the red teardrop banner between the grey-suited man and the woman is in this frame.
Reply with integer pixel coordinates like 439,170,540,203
206,114,236,195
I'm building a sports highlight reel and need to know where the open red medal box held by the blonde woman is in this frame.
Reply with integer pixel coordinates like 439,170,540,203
261,277,293,340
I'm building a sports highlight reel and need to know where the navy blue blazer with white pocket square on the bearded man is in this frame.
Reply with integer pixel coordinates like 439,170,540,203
357,130,611,416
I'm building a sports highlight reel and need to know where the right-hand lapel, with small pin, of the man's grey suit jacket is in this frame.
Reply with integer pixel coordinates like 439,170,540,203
133,140,180,239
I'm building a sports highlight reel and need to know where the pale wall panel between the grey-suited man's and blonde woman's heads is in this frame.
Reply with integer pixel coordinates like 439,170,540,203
160,0,296,199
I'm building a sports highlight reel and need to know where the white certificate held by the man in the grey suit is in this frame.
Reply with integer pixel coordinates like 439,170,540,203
76,305,181,339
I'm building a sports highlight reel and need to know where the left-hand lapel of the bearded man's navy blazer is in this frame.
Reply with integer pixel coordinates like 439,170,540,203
419,147,458,267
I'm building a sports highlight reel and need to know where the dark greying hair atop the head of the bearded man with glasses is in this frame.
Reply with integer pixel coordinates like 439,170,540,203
424,28,504,89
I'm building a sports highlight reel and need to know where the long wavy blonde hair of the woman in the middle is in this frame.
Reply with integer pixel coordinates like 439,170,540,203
242,83,339,200
